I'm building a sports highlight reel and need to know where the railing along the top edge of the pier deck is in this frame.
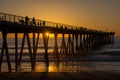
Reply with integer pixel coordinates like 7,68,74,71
0,12,98,31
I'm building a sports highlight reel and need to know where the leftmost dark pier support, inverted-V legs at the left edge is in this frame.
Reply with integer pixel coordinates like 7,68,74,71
0,32,12,72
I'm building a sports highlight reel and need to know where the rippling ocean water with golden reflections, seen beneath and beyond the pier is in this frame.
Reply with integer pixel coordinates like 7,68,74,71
0,37,120,72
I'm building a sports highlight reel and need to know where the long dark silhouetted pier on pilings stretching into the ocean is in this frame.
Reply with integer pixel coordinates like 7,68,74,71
0,13,115,72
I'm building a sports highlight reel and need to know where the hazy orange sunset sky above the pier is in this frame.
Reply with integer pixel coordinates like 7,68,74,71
0,0,120,35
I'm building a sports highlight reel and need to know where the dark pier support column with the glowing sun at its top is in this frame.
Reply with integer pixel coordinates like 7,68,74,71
43,32,49,71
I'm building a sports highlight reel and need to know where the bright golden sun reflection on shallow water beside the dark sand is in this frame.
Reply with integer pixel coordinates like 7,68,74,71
35,62,91,72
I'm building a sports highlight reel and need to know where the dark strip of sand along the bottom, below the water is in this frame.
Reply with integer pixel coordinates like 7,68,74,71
0,71,120,80
